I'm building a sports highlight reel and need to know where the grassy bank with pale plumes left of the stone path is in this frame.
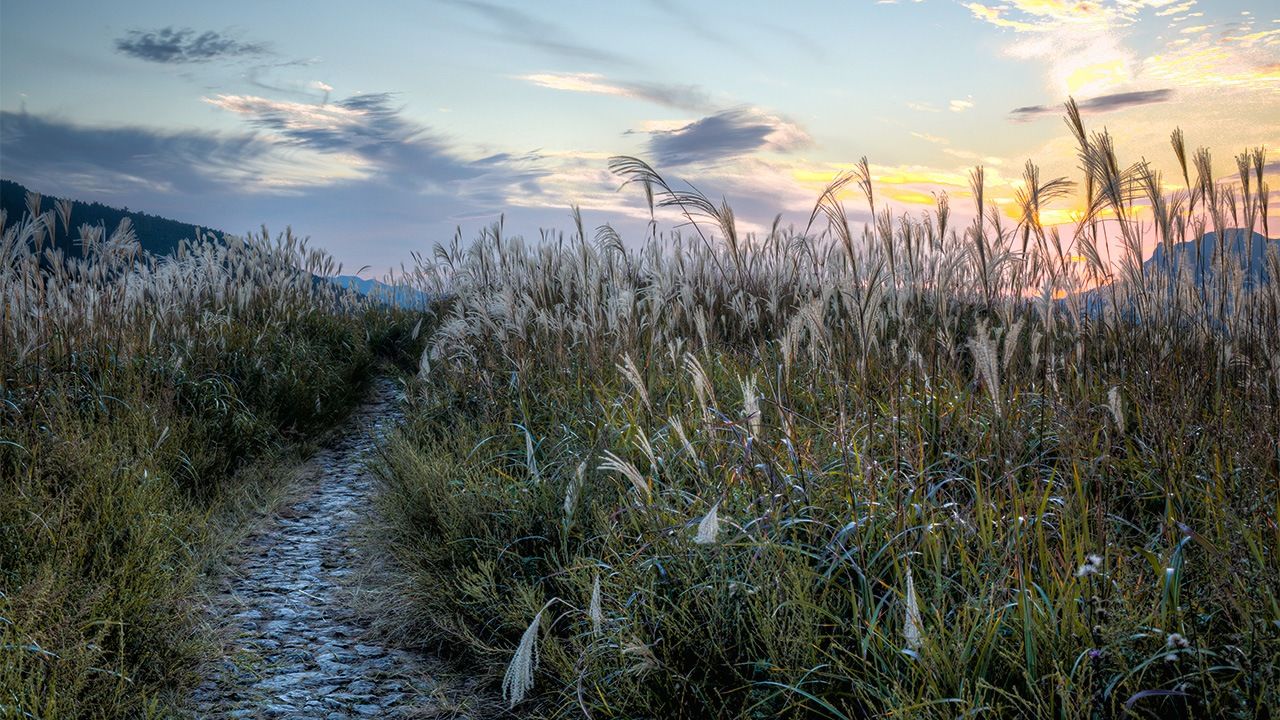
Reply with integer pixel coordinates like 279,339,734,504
0,205,417,717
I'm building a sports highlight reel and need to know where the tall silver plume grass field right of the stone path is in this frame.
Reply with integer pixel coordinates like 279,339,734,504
380,104,1280,719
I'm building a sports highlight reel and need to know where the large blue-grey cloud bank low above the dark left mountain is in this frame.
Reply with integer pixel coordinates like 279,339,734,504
0,105,555,266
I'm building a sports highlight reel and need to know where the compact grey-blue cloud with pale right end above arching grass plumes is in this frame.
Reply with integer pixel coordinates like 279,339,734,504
649,108,810,167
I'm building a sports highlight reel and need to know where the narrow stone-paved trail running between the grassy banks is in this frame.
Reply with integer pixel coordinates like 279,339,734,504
192,382,434,720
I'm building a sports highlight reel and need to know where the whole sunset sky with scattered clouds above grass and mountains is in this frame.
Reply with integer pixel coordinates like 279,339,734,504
0,0,1280,275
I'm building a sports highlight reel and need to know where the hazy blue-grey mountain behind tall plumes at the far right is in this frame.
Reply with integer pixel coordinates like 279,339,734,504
1142,228,1280,288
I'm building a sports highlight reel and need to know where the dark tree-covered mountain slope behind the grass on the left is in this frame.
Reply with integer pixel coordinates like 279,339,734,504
0,179,224,258
